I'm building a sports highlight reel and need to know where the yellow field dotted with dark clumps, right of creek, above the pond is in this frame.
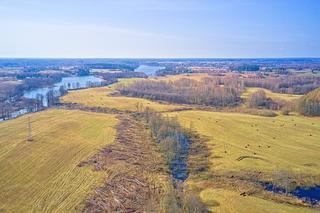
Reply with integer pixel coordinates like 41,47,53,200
170,111,320,178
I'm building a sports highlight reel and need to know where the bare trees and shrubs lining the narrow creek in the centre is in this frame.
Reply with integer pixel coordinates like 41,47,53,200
137,103,208,213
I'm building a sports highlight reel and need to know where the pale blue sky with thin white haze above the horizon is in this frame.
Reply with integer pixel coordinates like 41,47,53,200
0,0,320,58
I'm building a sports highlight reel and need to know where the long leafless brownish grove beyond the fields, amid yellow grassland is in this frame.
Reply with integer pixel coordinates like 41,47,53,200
118,77,243,107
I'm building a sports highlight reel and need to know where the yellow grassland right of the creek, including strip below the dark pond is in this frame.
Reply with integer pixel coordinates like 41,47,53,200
168,111,320,212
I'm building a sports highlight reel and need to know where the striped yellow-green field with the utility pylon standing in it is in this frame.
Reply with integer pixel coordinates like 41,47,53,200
0,110,117,212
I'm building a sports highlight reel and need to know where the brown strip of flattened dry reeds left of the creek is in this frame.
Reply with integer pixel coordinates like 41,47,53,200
79,115,171,212
